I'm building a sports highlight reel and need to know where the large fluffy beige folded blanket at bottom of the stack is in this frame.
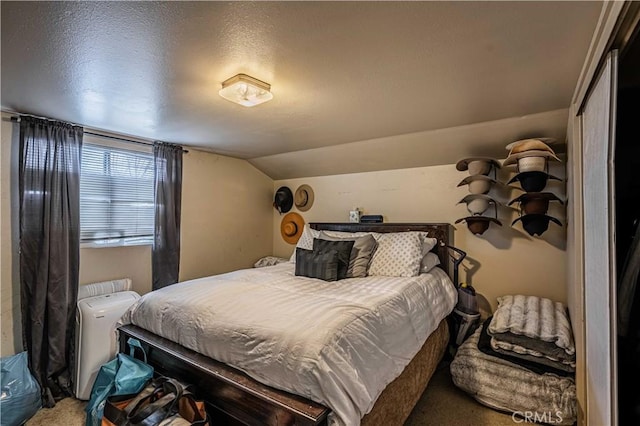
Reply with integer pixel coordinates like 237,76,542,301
450,327,577,425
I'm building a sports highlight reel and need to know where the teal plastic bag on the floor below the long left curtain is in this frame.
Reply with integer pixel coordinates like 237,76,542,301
0,351,42,426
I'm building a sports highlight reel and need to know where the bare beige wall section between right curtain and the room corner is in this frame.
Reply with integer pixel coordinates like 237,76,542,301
180,150,273,280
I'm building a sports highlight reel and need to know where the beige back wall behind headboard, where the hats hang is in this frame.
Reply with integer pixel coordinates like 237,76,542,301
273,161,567,309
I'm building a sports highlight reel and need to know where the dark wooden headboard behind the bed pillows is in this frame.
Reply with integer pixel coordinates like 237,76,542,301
309,222,453,279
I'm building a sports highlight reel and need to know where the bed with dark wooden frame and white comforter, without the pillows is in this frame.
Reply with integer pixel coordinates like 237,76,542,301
118,223,456,426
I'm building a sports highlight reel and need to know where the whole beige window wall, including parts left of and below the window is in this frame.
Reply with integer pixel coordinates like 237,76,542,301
0,114,273,356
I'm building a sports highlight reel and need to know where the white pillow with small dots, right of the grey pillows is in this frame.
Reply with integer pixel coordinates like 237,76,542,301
369,231,426,277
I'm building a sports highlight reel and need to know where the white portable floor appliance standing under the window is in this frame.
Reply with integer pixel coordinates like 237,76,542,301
75,279,140,400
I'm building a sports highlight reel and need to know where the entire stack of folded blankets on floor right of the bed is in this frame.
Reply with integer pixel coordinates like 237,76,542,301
450,295,577,425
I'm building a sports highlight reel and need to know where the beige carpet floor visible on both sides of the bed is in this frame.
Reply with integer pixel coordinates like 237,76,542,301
26,361,515,426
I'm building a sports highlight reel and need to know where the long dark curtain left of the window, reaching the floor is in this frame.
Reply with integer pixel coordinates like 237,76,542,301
19,117,83,407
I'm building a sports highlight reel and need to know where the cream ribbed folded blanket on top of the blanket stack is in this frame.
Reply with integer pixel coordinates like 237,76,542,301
488,295,576,362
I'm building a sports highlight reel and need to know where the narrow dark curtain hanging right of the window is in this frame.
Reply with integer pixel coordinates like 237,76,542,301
152,143,182,290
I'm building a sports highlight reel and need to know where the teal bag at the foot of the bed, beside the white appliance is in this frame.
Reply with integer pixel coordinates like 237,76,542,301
85,338,153,426
